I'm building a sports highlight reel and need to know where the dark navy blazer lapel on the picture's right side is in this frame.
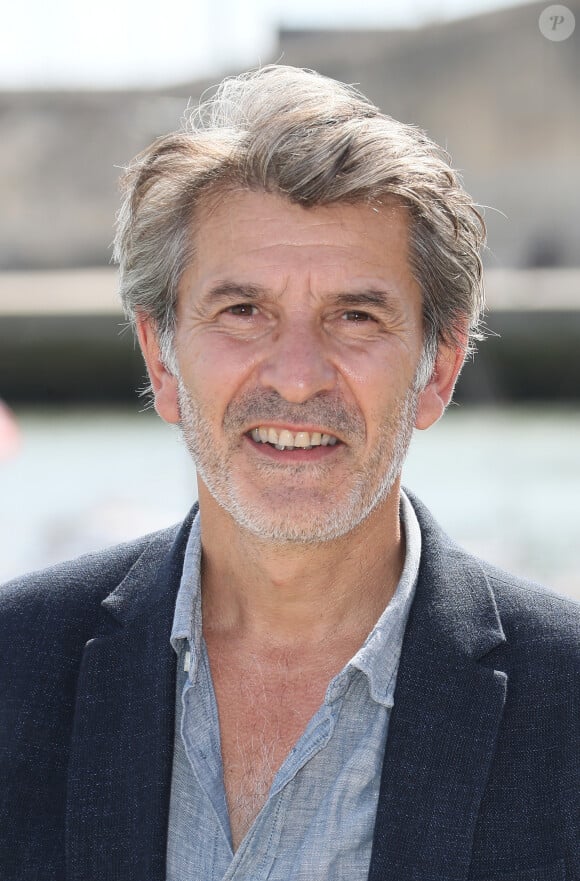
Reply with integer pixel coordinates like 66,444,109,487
369,499,507,881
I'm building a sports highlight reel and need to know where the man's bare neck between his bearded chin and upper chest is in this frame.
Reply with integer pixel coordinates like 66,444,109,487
199,482,405,647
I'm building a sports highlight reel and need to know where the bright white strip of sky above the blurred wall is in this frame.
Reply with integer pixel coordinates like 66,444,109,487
0,0,526,89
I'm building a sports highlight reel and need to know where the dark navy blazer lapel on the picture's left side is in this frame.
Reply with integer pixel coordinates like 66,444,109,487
66,509,196,881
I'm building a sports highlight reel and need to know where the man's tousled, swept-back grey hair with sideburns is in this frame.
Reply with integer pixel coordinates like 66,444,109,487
114,65,485,382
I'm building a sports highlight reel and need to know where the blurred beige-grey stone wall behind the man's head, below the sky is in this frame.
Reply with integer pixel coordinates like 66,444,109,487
0,0,580,270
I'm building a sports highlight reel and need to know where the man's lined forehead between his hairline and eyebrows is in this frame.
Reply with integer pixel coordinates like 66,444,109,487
184,190,414,290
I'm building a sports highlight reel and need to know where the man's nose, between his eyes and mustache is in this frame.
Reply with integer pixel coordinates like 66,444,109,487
260,315,336,404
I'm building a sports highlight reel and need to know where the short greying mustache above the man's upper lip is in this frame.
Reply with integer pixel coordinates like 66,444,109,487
224,390,366,437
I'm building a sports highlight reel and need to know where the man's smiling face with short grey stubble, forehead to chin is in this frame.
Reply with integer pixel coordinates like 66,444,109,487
150,191,440,543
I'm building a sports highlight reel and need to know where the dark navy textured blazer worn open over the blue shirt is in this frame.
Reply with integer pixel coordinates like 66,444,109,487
0,499,580,881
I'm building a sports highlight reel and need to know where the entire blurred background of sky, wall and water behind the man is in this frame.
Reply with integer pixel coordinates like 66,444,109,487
0,0,580,598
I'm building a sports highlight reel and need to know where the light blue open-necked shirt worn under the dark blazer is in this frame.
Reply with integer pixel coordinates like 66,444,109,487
167,494,421,881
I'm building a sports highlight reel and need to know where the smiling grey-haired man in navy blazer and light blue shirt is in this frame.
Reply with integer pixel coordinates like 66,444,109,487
0,66,580,881
